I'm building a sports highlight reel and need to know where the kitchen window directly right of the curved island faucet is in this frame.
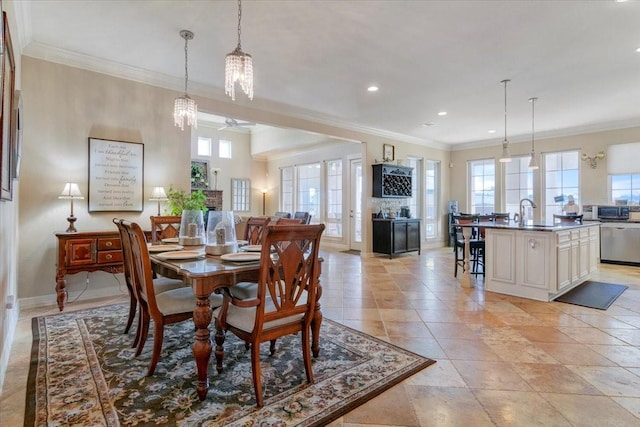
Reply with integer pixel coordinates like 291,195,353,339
544,151,580,222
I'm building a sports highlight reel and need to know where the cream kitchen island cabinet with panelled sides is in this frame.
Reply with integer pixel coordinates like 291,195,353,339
479,223,600,301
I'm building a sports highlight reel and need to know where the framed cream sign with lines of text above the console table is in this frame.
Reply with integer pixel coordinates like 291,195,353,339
88,137,144,212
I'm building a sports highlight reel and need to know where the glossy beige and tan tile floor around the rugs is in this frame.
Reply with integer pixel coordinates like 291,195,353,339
0,248,640,427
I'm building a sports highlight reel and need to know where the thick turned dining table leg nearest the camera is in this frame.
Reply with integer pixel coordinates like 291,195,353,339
193,294,213,400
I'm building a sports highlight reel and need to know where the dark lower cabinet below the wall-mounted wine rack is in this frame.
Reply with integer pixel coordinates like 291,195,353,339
373,218,420,258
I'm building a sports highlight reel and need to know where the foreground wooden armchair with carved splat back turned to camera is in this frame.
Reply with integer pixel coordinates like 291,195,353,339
213,224,324,407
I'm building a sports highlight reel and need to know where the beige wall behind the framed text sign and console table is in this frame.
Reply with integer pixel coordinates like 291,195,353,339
18,57,191,306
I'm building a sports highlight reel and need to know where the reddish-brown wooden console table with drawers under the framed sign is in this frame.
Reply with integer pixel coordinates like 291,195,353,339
56,230,123,311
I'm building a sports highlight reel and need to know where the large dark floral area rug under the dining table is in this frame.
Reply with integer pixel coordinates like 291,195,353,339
25,305,434,426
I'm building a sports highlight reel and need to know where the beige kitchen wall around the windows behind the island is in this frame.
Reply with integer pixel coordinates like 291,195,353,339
450,127,640,218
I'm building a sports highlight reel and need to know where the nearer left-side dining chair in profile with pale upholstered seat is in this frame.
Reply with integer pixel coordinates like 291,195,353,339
121,220,222,376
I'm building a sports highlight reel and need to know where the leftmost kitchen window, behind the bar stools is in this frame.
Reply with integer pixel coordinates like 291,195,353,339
468,159,496,215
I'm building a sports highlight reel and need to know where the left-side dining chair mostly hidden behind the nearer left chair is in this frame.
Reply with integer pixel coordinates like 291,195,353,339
113,218,184,347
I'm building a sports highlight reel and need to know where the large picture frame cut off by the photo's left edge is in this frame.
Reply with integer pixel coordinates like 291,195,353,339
0,12,16,200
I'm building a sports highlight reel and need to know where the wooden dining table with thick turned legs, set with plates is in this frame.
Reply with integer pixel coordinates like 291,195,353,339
149,246,322,401
